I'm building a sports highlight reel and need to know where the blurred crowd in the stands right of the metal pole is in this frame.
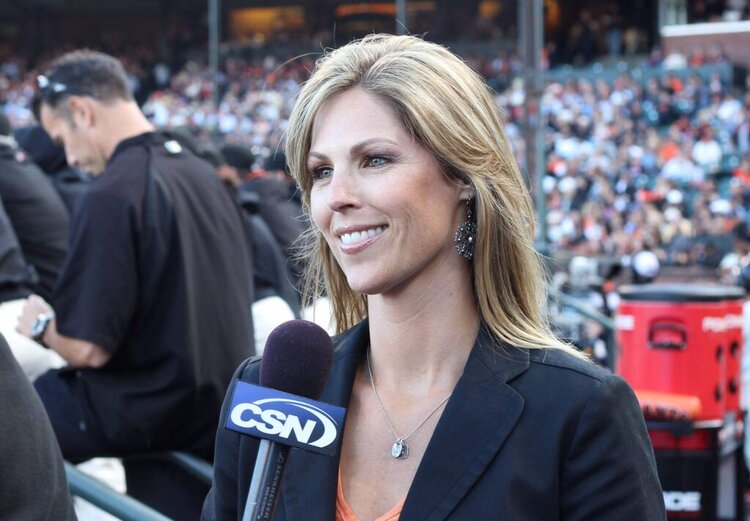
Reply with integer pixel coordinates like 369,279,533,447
532,65,750,268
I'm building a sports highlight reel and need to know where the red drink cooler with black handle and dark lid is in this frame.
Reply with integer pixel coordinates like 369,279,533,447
616,284,744,420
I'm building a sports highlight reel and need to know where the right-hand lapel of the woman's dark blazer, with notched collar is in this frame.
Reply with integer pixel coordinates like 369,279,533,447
402,327,529,521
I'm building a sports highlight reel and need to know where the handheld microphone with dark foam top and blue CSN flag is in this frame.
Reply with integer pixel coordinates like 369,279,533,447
226,320,346,521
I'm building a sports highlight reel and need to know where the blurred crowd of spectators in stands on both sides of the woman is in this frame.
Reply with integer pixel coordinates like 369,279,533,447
0,40,750,278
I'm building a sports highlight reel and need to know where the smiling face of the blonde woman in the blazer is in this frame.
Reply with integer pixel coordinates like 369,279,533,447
308,88,469,295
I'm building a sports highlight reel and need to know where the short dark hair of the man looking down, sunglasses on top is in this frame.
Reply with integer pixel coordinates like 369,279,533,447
33,49,133,119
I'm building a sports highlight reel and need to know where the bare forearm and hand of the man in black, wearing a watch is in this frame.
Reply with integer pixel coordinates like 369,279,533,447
16,295,111,368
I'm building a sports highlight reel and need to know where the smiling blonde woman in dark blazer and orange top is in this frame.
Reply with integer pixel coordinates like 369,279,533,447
204,35,665,521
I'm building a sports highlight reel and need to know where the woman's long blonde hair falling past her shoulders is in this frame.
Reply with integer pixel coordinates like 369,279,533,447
286,35,578,353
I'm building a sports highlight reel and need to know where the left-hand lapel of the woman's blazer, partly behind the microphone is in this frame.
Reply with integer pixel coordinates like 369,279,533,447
281,320,369,521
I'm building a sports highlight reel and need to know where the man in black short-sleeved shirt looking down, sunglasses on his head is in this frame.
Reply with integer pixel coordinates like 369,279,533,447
18,51,253,519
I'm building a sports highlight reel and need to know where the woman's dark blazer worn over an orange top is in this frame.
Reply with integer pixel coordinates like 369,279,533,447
202,321,666,521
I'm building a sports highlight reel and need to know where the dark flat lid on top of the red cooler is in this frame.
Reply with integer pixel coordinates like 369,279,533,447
617,283,745,302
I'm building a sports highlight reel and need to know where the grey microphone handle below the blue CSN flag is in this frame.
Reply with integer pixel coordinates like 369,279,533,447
242,439,289,521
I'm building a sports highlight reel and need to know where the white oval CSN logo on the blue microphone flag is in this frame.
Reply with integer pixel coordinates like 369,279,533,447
230,398,338,448
